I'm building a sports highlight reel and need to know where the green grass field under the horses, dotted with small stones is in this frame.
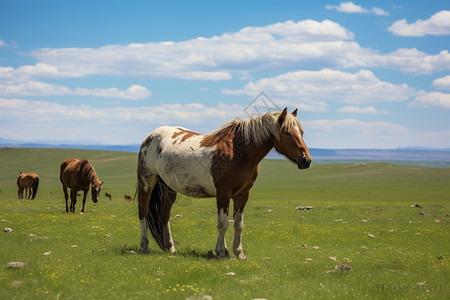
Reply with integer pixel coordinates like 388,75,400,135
0,149,450,299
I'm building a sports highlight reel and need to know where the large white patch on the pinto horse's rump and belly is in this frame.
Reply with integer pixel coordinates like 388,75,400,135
145,126,216,198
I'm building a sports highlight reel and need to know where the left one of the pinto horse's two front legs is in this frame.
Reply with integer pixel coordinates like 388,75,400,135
216,192,230,258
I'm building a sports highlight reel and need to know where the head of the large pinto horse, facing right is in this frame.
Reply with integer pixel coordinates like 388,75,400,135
274,108,312,169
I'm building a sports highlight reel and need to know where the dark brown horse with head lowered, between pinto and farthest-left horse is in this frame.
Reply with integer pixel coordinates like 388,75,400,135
59,158,103,214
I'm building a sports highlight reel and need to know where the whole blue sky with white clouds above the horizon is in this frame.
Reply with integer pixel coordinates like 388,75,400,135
0,0,450,148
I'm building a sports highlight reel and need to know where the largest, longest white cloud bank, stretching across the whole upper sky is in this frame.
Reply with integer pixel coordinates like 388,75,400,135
0,20,450,84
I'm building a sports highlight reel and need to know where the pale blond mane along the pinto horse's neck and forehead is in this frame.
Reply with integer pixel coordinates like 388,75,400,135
202,112,302,145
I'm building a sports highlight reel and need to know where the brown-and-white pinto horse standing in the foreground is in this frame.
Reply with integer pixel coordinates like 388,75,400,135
137,109,311,259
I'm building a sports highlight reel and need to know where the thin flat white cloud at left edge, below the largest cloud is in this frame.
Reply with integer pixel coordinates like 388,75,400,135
0,81,151,100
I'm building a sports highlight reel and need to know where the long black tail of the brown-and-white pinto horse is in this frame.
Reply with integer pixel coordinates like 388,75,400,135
147,177,177,251
